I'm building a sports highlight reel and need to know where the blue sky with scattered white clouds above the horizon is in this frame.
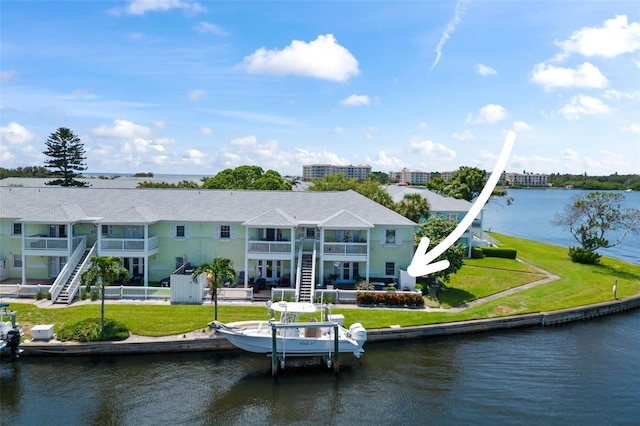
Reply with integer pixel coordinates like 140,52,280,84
0,0,640,176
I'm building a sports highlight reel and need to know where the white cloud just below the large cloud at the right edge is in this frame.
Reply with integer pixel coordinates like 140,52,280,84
531,62,609,90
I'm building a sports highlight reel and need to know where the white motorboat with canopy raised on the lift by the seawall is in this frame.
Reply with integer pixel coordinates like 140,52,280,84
209,302,367,359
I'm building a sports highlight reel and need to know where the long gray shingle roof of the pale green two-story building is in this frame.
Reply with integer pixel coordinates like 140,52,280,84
0,186,415,226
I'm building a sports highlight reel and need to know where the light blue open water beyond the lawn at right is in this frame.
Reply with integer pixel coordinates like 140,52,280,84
483,189,640,264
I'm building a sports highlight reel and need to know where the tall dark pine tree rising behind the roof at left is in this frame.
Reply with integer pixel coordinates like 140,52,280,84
43,127,87,186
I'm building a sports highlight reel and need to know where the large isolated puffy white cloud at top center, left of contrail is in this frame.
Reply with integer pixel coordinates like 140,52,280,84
243,34,360,81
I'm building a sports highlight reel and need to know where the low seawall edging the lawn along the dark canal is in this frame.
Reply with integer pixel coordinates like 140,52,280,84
21,295,640,356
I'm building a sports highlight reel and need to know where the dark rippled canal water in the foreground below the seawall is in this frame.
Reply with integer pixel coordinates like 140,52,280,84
0,310,640,425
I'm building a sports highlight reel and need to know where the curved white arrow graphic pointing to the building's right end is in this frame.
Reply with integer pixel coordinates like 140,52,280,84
407,131,516,277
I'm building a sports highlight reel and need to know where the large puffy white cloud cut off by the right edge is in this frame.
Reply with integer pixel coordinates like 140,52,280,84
556,15,640,59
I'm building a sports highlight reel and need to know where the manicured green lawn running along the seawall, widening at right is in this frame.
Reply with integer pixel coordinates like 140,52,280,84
9,234,640,336
